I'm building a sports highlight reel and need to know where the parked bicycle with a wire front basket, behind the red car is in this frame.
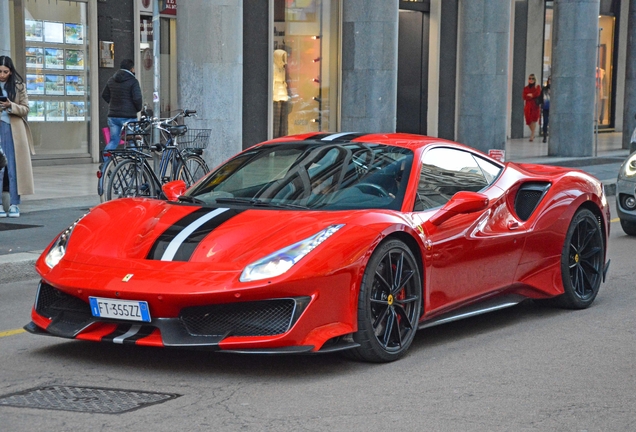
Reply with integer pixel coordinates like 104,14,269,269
106,110,210,200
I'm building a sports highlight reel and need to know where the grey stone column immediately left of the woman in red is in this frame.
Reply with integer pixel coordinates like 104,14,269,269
457,0,512,152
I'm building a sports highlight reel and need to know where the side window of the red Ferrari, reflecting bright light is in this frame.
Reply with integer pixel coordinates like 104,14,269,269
413,147,494,211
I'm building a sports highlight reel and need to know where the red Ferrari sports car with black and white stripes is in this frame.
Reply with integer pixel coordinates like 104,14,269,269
25,133,610,362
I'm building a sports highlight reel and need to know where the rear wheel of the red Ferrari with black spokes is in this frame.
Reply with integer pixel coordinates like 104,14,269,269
556,209,605,309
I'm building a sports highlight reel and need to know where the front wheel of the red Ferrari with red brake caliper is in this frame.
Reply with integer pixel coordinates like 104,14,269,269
346,240,422,362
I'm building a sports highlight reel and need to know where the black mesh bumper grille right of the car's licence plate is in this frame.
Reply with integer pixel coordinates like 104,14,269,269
180,299,296,336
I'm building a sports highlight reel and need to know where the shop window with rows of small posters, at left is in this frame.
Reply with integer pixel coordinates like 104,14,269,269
22,0,90,158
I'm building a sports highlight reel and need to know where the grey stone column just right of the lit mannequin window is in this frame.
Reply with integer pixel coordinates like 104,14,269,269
340,0,399,132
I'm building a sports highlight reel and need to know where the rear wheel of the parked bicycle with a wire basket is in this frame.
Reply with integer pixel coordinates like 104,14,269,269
106,159,157,200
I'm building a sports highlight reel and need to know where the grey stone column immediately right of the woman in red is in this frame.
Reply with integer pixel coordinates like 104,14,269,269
548,0,599,156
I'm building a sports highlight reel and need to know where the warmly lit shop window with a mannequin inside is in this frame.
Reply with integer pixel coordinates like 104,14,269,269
272,0,340,138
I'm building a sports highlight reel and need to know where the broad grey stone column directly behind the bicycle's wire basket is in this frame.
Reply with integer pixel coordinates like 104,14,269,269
177,0,243,167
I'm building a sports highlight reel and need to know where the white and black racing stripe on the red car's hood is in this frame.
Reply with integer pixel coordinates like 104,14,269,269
147,208,245,261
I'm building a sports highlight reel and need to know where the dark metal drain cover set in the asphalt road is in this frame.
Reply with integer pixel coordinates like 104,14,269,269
0,386,181,414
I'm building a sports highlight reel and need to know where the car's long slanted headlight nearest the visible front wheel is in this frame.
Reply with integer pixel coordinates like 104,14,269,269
239,225,344,282
